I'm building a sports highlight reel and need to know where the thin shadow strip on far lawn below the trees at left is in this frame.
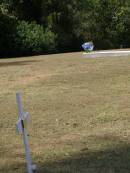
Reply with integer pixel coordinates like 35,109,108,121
0,60,37,67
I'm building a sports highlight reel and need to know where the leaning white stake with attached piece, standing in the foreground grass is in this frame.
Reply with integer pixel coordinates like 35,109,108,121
16,92,36,173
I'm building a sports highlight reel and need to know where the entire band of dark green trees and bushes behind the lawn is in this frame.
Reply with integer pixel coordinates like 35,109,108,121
0,0,130,56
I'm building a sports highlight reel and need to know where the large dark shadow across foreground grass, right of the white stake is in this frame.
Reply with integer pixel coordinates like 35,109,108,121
38,144,130,173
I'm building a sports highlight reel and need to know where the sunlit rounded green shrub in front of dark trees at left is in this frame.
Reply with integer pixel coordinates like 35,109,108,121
15,21,56,55
